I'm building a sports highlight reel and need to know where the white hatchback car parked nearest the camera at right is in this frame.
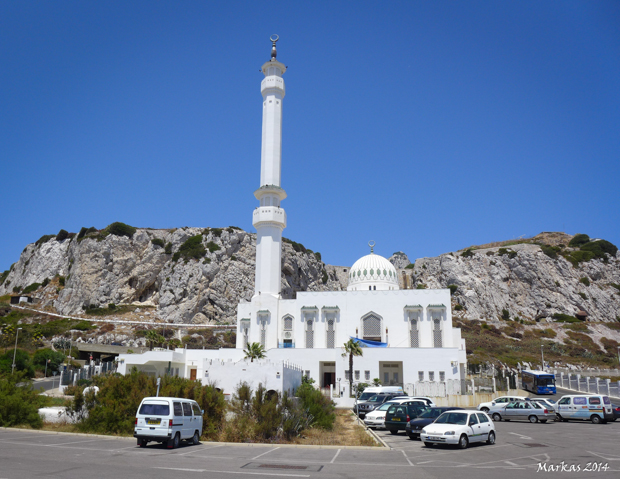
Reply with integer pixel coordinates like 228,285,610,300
420,410,495,449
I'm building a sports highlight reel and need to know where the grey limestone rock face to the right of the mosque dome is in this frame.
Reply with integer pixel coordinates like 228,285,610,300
406,244,620,321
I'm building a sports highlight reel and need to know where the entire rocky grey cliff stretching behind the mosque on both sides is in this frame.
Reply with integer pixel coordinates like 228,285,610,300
0,229,620,323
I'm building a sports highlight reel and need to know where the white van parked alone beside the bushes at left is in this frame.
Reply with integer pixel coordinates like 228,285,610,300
133,397,203,449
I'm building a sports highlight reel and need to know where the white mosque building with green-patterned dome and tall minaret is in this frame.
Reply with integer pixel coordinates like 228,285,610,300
119,36,466,402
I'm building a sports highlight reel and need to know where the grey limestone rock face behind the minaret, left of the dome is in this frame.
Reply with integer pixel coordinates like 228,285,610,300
0,228,346,324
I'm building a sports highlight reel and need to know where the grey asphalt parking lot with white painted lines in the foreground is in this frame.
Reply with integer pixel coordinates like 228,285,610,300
0,421,620,479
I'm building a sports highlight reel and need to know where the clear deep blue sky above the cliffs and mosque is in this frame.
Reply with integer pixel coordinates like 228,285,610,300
0,1,620,271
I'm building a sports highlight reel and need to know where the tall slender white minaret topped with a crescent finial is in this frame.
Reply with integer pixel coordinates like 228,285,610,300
252,35,286,298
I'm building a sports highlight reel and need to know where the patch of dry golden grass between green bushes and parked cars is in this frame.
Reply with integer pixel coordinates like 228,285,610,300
291,409,381,446
